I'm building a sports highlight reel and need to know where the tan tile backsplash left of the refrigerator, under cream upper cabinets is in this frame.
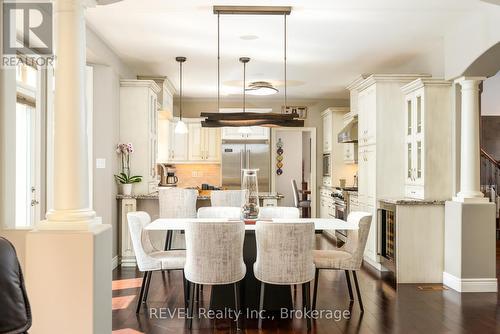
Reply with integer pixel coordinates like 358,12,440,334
175,164,221,188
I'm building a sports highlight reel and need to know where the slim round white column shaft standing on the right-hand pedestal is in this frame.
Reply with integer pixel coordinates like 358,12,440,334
453,77,487,202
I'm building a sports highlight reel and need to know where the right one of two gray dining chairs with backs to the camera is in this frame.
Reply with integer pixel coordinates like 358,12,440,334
253,221,314,330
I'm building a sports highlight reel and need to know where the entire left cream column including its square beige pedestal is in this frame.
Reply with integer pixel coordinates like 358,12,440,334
25,0,112,334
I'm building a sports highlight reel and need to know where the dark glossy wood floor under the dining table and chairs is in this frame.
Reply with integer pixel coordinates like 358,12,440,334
113,238,500,334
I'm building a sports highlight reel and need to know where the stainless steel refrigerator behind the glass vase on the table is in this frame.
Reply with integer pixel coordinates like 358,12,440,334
222,140,271,192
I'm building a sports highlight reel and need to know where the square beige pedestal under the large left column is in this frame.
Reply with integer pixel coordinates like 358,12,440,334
25,223,112,334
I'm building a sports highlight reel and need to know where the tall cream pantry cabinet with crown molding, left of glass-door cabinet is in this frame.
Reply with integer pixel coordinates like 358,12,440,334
348,74,428,269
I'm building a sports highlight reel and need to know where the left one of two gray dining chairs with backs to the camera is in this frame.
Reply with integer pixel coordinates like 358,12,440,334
184,221,246,328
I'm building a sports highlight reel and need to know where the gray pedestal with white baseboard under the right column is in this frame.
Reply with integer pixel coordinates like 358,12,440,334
443,201,498,292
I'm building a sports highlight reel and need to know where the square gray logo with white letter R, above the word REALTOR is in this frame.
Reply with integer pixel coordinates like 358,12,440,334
2,2,52,56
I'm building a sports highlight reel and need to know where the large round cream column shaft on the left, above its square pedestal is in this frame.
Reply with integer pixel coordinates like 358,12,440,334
39,0,95,230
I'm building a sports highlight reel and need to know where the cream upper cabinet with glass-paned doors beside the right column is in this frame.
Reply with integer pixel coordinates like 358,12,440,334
401,79,452,200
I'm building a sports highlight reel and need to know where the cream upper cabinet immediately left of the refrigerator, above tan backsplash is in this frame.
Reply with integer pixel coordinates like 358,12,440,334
188,121,221,163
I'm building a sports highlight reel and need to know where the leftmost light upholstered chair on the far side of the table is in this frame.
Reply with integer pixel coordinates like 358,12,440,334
158,187,198,250
